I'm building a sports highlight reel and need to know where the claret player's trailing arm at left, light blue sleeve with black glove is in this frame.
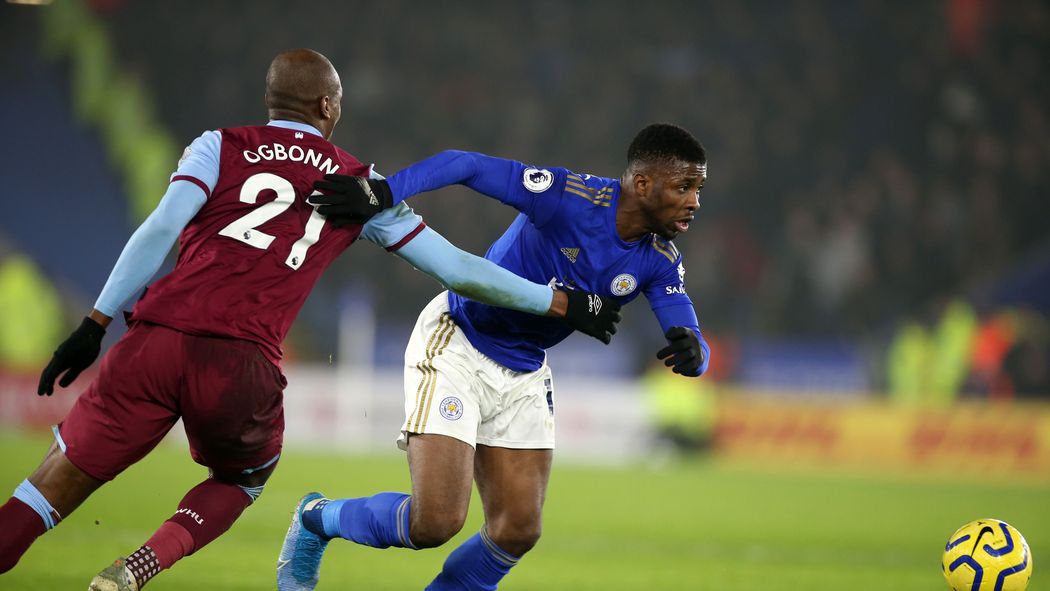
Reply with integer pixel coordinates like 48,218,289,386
37,182,207,396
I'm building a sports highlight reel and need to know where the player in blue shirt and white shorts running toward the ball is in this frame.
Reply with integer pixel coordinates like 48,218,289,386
277,124,711,591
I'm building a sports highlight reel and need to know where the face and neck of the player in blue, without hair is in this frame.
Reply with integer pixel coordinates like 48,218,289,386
616,159,708,242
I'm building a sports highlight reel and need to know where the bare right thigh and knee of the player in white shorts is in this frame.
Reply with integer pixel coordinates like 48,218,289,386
474,444,554,529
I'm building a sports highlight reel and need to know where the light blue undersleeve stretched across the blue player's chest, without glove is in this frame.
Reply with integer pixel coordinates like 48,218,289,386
395,225,554,316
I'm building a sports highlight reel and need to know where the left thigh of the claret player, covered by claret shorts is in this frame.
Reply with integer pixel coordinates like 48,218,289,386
56,324,182,481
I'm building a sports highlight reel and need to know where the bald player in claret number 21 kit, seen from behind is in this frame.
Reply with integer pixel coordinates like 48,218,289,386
0,49,618,591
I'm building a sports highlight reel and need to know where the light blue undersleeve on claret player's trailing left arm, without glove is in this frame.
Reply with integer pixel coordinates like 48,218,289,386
95,173,208,318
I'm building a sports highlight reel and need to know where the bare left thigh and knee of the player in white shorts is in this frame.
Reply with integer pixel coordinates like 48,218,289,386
408,434,475,522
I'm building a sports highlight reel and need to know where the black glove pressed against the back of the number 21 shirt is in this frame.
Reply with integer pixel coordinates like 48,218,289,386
307,174,394,228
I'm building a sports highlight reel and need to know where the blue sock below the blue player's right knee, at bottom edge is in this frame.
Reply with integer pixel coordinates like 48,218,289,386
424,528,520,591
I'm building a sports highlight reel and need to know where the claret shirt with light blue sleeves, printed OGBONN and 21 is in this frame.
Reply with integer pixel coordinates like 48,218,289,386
132,122,422,363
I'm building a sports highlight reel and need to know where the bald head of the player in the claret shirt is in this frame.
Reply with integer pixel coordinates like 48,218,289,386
266,49,342,139
